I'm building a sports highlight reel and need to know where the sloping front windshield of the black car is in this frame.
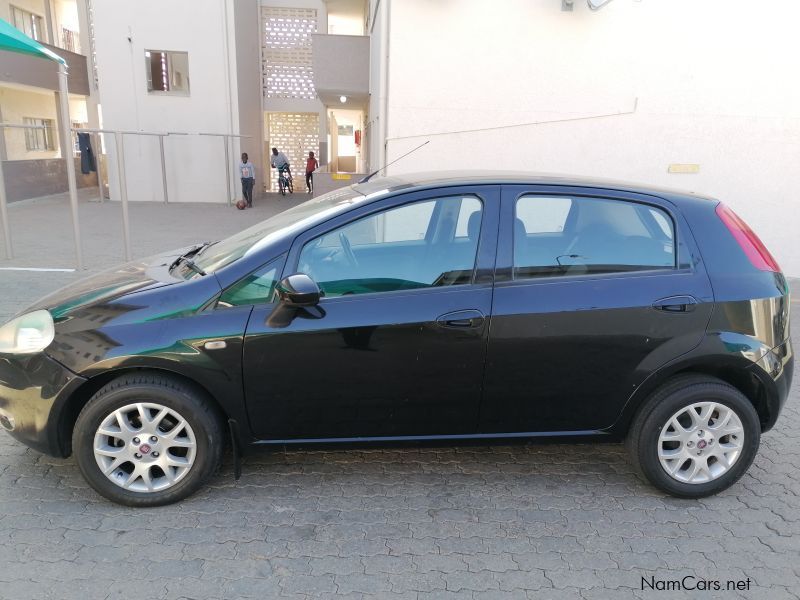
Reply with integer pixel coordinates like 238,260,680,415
192,187,365,273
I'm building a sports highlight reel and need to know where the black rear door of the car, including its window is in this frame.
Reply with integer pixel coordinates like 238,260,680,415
480,186,713,432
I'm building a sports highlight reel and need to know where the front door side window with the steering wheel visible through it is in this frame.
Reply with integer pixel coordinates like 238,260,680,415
298,196,482,298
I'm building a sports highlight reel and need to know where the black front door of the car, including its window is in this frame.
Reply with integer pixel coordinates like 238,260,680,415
243,186,500,440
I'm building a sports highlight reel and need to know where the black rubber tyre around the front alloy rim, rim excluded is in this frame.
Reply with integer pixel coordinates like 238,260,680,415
72,374,225,507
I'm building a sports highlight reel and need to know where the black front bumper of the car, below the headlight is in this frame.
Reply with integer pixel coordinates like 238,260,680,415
0,354,86,456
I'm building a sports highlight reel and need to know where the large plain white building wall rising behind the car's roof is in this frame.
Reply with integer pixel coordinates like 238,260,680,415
378,0,800,276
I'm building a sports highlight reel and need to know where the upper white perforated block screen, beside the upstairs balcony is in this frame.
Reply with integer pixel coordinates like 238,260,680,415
261,6,317,100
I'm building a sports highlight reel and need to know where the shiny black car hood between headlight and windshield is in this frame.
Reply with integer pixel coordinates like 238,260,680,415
20,246,196,320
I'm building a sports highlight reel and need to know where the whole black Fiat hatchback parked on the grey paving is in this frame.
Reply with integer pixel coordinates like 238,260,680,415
0,173,793,506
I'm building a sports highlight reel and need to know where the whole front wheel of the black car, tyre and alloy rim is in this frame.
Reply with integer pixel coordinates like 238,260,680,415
72,375,223,506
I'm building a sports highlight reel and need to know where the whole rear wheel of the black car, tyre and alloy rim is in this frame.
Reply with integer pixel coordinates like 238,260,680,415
627,375,761,498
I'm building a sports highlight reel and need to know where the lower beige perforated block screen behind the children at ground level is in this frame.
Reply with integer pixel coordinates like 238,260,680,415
265,113,319,192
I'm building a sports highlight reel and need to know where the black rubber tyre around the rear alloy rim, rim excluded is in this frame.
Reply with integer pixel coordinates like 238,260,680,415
626,375,761,498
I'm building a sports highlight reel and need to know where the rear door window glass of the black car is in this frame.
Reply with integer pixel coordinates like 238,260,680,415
513,196,675,279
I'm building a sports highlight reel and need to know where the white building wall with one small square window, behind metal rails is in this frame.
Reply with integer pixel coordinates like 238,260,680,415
94,0,238,202
